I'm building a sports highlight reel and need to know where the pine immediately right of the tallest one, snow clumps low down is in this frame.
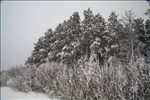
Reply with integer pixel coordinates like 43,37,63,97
90,13,107,66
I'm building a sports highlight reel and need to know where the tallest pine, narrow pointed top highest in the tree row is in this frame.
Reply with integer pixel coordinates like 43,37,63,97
81,8,94,60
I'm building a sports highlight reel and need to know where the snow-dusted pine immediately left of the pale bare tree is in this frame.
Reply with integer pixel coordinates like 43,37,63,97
107,12,123,56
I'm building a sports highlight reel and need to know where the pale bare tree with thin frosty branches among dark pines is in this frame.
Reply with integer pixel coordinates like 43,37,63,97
121,10,136,63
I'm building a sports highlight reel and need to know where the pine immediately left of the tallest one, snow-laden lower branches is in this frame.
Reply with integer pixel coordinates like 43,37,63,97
57,12,81,64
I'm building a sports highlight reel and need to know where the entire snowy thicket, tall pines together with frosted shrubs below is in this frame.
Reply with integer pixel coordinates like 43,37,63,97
0,9,150,100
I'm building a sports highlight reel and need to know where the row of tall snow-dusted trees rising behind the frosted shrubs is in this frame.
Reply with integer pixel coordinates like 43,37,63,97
26,8,150,66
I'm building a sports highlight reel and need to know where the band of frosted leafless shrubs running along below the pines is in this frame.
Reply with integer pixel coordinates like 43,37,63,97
1,58,150,100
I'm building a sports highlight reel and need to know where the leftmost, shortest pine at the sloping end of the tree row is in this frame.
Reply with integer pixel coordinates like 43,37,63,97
26,29,55,65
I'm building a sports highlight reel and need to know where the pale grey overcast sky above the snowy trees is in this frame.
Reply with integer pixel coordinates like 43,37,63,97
1,1,150,70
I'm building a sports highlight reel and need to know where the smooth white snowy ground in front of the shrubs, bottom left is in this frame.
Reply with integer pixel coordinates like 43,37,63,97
0,87,58,100
